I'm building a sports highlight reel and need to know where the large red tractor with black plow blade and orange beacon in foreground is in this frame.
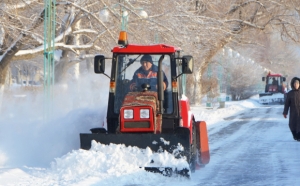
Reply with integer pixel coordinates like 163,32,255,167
80,31,210,175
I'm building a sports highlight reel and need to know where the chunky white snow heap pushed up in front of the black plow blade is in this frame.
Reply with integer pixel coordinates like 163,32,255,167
51,141,188,176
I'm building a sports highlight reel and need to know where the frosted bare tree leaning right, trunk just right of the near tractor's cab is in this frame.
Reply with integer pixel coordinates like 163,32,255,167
163,0,300,104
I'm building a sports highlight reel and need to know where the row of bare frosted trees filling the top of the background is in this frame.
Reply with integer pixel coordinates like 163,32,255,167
0,0,300,104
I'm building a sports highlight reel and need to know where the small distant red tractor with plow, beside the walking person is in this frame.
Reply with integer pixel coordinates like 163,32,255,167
259,72,286,104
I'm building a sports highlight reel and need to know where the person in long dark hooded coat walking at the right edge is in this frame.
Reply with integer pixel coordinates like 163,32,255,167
283,77,300,141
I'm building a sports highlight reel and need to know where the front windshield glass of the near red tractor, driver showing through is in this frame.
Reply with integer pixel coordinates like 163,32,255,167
114,54,173,114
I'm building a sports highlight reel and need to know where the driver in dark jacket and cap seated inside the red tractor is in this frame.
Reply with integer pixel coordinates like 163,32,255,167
130,55,168,91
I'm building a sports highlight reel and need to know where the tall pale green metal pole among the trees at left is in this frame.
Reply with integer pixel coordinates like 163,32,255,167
44,0,56,122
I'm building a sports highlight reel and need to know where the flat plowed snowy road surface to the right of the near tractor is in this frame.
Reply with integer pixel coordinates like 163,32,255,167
193,106,300,186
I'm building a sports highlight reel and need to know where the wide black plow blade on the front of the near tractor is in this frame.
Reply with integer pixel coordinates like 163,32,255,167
80,128,191,177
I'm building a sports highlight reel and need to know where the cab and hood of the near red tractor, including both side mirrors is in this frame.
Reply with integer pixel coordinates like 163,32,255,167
94,31,193,133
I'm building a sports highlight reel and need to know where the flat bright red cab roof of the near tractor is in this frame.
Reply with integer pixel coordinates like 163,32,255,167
112,44,181,54
